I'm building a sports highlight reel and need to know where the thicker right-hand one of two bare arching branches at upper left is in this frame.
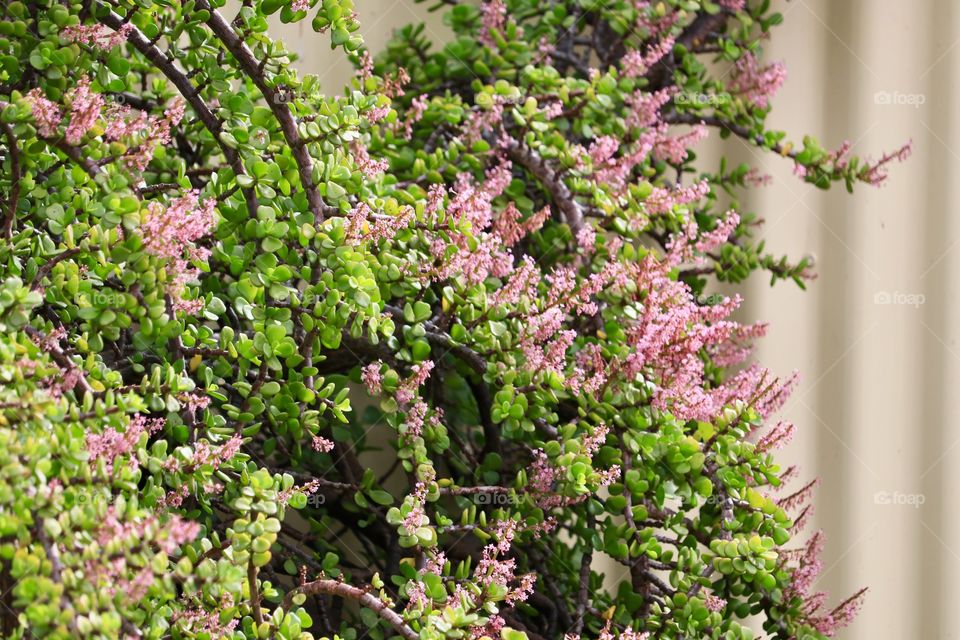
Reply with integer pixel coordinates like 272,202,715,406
196,0,336,222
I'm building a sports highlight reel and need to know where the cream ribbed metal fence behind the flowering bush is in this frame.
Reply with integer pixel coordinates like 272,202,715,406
274,0,960,640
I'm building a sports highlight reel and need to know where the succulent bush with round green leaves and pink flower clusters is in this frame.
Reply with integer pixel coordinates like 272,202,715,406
0,0,909,640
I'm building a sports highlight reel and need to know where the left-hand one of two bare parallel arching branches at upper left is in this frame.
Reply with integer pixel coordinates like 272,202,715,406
100,11,258,217
